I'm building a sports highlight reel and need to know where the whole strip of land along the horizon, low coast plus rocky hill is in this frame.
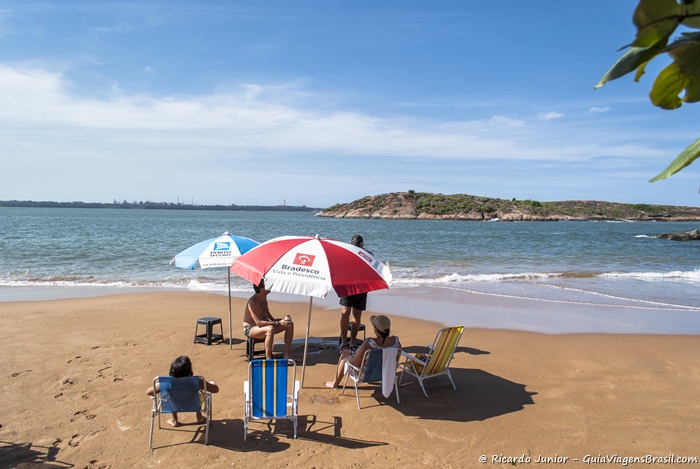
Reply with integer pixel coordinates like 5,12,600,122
5,191,700,222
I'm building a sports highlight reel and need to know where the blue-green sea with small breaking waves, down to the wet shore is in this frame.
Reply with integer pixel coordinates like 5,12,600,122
0,207,700,334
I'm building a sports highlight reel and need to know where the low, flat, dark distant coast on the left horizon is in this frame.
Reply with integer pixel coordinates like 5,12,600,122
0,200,321,212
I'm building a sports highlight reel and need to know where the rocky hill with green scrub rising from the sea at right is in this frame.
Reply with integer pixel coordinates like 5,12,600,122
316,191,700,222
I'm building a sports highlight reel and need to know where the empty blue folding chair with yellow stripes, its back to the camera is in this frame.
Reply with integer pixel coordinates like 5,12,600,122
243,358,300,441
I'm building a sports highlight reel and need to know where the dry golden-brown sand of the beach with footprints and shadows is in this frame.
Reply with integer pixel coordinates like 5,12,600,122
0,292,700,468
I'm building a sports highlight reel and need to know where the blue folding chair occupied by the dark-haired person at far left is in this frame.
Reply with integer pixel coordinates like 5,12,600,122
149,376,211,450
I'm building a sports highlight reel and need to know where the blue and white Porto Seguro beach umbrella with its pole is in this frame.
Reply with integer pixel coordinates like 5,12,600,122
170,232,260,349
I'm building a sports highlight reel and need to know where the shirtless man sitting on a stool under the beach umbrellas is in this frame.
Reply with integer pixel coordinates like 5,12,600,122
243,280,294,359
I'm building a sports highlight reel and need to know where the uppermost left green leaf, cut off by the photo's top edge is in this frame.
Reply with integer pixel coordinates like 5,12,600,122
632,0,685,47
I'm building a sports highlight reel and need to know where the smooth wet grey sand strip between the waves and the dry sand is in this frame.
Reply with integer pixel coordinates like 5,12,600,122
0,286,700,335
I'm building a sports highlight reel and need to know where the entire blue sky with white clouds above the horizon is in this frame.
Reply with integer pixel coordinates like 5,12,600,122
0,0,700,207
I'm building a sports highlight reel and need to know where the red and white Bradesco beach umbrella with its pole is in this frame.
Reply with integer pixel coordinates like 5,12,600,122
231,235,391,386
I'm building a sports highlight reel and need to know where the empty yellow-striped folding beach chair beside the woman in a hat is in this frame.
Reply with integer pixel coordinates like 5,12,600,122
399,326,464,397
